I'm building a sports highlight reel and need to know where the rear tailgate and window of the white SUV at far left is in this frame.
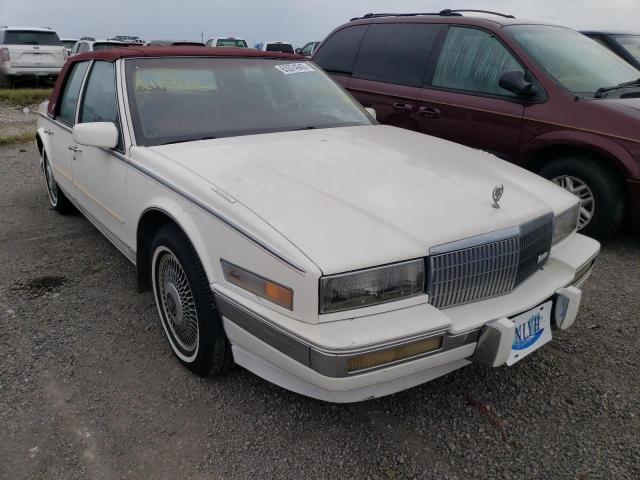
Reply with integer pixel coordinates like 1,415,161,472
4,30,66,68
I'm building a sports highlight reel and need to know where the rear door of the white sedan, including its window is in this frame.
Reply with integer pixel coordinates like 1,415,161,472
45,62,89,198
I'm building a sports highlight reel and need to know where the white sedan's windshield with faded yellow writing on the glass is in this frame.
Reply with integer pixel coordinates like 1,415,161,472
126,57,371,146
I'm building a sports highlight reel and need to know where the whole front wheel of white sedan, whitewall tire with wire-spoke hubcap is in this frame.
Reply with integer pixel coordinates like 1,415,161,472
151,224,233,377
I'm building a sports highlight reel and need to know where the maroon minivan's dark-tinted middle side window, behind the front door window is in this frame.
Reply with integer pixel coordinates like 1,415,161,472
353,23,441,87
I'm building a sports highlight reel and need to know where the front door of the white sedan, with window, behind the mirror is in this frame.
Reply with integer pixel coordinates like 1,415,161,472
72,61,127,239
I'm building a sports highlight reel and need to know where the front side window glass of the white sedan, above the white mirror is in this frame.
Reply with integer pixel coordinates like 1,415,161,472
78,61,122,148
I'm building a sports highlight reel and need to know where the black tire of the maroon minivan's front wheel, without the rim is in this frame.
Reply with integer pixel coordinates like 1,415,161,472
538,156,627,240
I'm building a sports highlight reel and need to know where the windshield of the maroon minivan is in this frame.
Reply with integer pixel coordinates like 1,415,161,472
506,25,640,95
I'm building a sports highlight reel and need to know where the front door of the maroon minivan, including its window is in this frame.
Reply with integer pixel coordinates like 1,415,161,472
417,26,524,159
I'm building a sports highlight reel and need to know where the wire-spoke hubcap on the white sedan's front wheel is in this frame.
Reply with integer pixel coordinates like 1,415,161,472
158,252,199,352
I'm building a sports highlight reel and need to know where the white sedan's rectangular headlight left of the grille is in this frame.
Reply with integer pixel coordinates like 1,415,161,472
320,259,424,313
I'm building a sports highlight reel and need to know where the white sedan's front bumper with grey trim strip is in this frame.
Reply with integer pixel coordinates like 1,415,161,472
213,235,599,402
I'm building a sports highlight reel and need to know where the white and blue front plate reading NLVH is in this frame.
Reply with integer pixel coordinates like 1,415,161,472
507,301,553,365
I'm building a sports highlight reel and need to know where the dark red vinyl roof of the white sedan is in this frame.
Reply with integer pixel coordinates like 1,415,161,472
47,46,306,116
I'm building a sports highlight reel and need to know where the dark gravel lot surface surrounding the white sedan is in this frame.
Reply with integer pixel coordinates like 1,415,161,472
0,145,640,480
